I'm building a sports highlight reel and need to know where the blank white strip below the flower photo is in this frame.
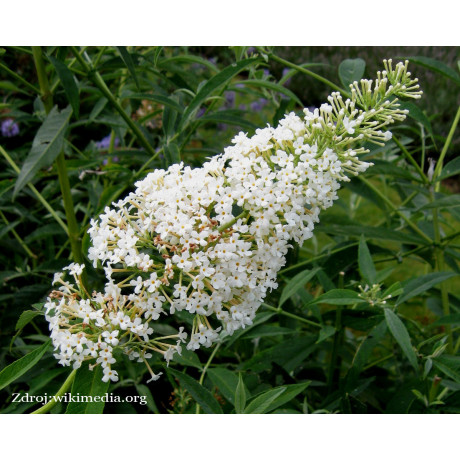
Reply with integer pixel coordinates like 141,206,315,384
0,415,459,460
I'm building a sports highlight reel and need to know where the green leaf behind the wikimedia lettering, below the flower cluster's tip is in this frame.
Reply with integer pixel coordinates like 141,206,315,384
66,363,110,414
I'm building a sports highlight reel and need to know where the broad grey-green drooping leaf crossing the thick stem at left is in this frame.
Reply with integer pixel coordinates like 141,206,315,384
13,106,72,198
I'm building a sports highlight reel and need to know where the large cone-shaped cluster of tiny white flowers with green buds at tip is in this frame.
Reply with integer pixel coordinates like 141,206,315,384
46,61,420,380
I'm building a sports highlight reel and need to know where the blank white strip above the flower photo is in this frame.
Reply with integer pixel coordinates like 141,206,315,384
0,0,459,46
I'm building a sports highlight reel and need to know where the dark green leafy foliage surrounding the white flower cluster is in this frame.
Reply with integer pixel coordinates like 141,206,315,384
0,47,460,413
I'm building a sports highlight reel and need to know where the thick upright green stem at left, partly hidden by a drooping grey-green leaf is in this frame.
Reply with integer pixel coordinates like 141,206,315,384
32,46,84,264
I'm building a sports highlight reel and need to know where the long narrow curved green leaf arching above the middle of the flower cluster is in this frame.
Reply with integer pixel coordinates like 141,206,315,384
178,57,259,131
